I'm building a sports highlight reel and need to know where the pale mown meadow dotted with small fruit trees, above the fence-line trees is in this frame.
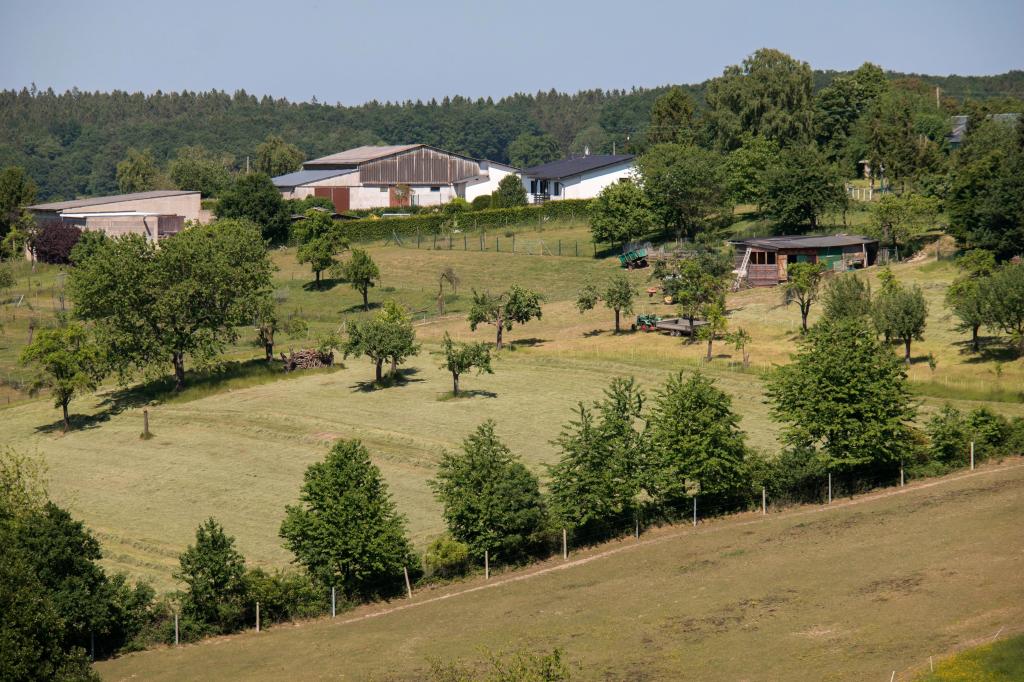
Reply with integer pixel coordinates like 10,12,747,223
0,218,1024,589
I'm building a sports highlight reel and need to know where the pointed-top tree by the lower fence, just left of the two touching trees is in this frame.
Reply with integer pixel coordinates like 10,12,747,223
430,421,547,562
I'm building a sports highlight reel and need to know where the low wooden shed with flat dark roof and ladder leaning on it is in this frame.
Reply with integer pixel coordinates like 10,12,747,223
732,235,879,288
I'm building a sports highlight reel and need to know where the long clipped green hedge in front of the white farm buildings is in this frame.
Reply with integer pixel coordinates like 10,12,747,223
339,199,590,242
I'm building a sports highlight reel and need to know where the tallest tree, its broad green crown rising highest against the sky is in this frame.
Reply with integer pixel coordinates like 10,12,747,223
705,48,814,151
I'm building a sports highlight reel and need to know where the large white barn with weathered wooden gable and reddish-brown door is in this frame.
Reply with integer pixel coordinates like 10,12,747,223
273,144,499,208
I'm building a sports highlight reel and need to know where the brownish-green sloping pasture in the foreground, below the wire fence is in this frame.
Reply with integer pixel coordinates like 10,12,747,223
96,459,1024,680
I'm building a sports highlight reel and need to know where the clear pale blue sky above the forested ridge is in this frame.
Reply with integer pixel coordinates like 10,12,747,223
0,0,1024,104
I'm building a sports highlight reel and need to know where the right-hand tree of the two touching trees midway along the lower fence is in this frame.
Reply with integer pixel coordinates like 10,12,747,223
646,372,746,506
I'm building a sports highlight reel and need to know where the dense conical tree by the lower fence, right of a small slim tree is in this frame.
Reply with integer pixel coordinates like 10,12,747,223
281,440,418,599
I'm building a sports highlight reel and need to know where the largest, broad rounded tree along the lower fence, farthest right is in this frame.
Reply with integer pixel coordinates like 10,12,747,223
767,317,916,472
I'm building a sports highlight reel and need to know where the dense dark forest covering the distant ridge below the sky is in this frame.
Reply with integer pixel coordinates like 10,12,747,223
0,56,1024,200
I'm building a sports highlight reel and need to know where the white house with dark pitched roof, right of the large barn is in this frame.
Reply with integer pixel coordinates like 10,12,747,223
522,154,635,204
